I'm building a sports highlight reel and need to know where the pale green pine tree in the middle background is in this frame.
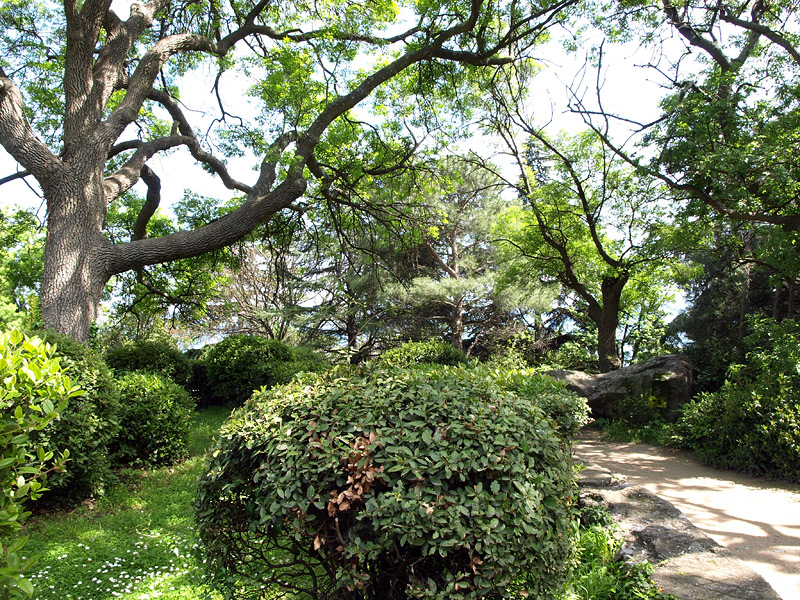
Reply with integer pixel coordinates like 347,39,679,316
386,156,552,355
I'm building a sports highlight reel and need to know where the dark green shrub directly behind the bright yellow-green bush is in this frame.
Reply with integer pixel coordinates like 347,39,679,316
32,331,119,503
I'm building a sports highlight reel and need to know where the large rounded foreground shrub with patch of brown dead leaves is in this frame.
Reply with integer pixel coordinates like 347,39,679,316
196,366,575,600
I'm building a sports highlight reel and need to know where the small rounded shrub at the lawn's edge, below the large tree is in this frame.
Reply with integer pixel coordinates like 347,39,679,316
113,372,194,465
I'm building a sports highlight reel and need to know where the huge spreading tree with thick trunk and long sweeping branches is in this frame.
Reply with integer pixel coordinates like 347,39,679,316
0,0,575,341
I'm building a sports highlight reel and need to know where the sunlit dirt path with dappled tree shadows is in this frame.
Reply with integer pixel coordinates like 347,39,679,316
574,430,800,600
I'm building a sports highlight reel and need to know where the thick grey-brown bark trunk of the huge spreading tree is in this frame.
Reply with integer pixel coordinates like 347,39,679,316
41,163,113,342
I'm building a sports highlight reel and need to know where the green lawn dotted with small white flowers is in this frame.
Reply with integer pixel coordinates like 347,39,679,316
23,408,230,600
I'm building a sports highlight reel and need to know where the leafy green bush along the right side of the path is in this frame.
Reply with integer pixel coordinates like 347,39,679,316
675,320,800,481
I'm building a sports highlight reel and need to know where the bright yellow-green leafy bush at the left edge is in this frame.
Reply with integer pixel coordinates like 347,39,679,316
0,330,81,599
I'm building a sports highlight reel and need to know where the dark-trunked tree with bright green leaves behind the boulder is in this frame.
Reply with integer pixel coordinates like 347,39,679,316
498,132,675,372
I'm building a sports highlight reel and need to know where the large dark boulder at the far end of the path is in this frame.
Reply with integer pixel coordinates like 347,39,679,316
547,354,694,420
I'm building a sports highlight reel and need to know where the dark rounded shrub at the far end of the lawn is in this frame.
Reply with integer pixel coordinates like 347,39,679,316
203,335,292,406
